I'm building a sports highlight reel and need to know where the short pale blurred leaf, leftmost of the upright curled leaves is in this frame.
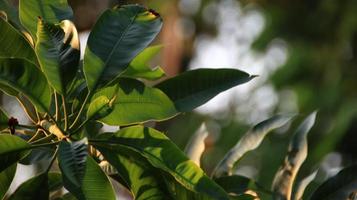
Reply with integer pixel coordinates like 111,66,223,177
185,123,208,166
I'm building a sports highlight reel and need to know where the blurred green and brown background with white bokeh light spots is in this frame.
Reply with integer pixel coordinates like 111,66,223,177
3,0,357,198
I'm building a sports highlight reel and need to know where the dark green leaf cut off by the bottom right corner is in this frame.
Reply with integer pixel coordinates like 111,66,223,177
310,165,357,200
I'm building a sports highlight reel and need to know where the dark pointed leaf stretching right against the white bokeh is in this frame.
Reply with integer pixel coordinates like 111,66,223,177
156,69,255,112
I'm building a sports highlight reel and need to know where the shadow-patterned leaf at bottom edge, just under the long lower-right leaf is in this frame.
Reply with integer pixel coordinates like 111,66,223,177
98,146,168,200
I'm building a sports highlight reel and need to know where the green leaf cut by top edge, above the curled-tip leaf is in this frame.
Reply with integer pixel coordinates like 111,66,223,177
19,0,73,41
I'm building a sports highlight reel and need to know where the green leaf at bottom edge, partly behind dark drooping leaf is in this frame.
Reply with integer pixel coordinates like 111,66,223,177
63,156,115,200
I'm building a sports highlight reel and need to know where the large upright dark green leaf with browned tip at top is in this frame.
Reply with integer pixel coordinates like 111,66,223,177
84,5,162,91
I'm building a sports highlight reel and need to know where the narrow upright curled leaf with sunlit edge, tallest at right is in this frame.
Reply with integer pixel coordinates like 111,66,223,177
272,112,316,199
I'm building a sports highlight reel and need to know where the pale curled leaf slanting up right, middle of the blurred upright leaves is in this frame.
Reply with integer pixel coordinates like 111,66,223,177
213,115,293,177
